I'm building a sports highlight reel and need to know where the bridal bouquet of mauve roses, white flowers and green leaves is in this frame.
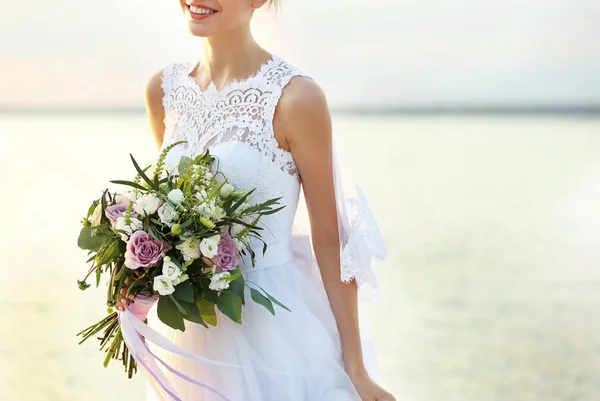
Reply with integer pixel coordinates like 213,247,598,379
78,142,289,377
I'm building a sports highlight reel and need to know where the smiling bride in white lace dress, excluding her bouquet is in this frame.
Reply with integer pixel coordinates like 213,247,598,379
118,0,395,401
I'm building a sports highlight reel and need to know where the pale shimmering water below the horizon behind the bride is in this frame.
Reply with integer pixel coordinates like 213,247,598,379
0,115,600,401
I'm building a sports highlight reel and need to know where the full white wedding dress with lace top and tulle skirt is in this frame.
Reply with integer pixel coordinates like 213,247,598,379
143,55,382,401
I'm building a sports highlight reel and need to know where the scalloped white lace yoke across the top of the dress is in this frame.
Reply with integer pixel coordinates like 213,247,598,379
163,55,308,178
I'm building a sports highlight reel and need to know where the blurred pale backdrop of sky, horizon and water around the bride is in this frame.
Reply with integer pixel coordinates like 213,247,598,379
0,0,600,401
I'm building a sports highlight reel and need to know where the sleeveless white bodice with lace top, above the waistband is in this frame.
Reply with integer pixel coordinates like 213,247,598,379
162,55,308,243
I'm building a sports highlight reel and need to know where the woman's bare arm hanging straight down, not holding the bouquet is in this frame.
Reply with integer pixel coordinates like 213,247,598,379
274,77,394,401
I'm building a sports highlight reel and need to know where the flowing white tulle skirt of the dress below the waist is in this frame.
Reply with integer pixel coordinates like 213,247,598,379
147,237,375,401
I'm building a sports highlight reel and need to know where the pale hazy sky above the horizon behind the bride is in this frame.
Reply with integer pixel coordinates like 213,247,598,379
0,0,600,108
